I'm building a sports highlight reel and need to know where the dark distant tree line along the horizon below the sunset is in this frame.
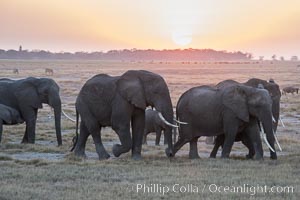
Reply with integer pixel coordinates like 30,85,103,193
0,48,252,61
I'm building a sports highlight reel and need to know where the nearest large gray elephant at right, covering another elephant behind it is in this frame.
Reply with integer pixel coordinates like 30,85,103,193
174,85,275,159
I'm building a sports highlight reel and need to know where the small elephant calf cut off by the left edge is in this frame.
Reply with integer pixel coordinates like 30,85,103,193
0,104,24,142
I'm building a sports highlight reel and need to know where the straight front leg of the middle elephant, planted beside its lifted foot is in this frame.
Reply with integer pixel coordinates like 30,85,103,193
131,109,145,160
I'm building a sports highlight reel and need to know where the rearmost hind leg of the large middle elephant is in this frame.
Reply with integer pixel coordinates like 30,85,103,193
74,121,90,158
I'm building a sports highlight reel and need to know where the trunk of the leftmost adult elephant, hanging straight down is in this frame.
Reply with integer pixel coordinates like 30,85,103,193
49,95,62,146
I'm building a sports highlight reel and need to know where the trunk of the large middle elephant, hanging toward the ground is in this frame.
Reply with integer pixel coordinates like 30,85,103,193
154,97,174,157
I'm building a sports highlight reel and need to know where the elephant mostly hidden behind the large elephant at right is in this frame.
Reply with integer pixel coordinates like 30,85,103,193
210,78,281,159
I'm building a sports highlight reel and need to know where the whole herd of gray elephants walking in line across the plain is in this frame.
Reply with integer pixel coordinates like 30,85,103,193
0,70,281,160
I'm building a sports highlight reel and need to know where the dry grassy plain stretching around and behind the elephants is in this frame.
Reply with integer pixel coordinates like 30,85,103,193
0,60,300,199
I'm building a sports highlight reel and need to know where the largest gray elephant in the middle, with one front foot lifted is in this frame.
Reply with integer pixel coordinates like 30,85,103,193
74,70,173,159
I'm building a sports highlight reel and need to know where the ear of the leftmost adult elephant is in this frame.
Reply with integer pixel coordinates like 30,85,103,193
14,78,43,108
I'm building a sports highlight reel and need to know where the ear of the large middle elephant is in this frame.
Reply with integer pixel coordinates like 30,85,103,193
117,71,147,110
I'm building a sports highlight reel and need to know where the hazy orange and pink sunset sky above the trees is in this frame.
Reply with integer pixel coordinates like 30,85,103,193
0,0,300,58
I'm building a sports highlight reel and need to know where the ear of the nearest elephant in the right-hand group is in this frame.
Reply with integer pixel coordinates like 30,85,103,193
222,86,249,122
